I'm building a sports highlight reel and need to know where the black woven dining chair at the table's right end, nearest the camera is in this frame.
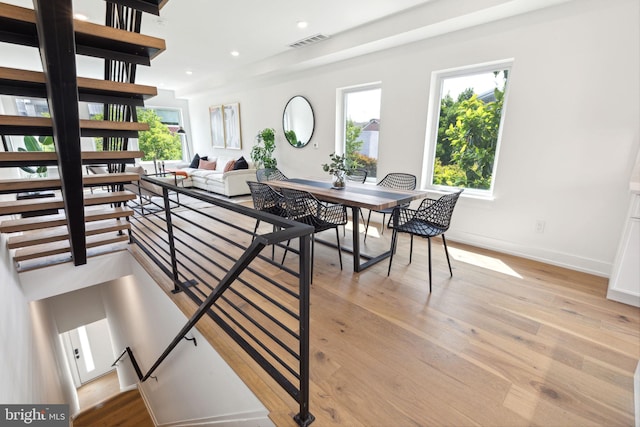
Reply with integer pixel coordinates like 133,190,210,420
387,189,463,292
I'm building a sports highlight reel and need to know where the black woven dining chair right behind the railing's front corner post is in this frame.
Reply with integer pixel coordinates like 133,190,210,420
282,188,347,278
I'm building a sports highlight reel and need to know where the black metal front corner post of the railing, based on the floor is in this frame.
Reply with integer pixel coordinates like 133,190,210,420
293,234,315,427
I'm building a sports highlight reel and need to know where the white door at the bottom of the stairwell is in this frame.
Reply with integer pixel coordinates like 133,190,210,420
65,319,115,384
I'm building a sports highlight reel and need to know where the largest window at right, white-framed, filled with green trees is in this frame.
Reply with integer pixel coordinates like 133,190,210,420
427,61,511,195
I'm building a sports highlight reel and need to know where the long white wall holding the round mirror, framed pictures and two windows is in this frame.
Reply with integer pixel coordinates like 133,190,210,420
182,0,640,276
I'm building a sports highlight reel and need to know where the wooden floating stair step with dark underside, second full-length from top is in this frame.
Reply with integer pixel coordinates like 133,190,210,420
0,67,158,107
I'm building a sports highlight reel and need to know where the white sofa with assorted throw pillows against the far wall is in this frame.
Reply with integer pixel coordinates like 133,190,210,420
178,157,256,197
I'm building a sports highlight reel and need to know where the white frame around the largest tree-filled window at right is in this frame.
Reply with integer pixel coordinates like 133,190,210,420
422,58,514,200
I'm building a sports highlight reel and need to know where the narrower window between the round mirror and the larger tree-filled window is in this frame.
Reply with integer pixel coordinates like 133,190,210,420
342,84,382,180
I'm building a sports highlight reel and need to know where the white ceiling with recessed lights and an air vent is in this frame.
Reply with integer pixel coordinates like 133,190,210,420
0,0,571,95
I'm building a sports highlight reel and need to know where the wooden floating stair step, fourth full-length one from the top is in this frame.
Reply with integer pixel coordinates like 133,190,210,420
0,151,144,167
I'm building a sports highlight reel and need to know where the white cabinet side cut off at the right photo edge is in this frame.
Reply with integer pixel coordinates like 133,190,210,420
607,193,640,307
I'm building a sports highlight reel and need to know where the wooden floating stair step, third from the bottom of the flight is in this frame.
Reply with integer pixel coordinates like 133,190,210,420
0,207,134,233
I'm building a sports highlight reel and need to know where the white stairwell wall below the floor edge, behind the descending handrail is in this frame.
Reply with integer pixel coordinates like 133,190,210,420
101,260,272,426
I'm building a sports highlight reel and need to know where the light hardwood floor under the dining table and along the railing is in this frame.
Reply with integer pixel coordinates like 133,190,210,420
131,205,640,426
